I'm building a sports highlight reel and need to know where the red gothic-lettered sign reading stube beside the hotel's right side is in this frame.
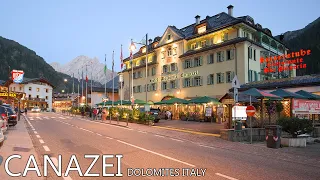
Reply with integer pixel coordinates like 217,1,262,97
260,49,311,73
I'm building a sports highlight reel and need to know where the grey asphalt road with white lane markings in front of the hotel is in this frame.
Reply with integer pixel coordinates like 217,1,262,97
26,113,320,180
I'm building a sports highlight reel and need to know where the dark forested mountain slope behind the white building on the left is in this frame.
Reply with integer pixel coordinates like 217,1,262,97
0,36,72,91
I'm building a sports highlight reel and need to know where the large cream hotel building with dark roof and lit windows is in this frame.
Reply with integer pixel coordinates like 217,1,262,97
120,5,295,102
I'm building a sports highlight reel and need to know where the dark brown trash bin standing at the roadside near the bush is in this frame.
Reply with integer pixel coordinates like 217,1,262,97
266,125,282,149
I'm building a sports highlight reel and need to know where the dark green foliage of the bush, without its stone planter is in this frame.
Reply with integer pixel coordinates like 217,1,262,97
277,117,312,138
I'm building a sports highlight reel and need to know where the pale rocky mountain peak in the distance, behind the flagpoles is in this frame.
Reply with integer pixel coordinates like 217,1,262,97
51,56,117,84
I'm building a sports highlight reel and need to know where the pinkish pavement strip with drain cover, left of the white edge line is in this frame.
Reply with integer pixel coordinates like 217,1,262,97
0,116,43,180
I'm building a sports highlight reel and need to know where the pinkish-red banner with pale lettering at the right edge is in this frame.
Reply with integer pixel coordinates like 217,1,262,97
292,99,320,114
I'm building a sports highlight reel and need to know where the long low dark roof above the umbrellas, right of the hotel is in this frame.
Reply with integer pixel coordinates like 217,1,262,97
239,74,320,91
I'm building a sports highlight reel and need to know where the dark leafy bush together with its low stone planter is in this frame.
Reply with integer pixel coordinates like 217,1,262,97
277,117,313,147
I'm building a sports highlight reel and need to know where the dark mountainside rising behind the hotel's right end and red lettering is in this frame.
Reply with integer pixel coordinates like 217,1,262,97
276,17,320,76
